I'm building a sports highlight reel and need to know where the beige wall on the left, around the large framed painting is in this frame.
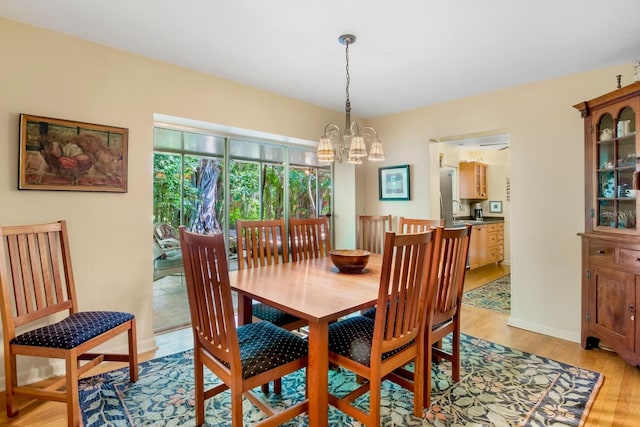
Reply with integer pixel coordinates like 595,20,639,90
0,19,344,384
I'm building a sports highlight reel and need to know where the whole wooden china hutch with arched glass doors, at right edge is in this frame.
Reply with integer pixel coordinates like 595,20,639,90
574,82,640,366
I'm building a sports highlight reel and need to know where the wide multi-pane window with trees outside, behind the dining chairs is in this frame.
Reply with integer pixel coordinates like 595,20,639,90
153,127,332,259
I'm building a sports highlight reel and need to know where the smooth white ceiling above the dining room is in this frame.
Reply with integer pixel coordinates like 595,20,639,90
0,0,640,117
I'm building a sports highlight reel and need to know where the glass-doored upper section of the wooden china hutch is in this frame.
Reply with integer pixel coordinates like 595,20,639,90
575,83,640,235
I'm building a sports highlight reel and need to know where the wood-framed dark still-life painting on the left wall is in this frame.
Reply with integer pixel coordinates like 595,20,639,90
18,114,129,193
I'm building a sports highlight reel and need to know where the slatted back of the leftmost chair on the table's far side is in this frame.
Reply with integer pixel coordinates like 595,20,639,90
236,218,289,270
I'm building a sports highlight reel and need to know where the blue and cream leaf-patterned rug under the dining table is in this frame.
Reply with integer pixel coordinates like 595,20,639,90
80,334,603,427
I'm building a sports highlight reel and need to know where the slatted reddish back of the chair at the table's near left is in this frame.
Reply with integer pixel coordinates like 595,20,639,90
180,227,241,367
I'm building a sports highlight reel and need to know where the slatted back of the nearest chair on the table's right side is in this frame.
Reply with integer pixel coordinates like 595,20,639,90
372,228,442,358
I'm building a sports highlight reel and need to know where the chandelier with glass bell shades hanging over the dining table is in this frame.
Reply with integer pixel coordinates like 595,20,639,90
317,34,384,165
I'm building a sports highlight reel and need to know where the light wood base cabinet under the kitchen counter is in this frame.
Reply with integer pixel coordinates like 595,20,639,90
469,222,504,269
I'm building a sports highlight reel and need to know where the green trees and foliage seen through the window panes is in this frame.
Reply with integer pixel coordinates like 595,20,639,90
153,152,331,237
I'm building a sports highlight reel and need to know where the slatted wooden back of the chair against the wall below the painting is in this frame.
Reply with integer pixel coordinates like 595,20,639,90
0,221,77,339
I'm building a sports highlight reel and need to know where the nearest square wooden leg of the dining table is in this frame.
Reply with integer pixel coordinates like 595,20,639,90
307,322,329,427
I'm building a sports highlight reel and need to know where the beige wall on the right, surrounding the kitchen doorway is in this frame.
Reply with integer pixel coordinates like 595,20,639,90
362,63,632,341
